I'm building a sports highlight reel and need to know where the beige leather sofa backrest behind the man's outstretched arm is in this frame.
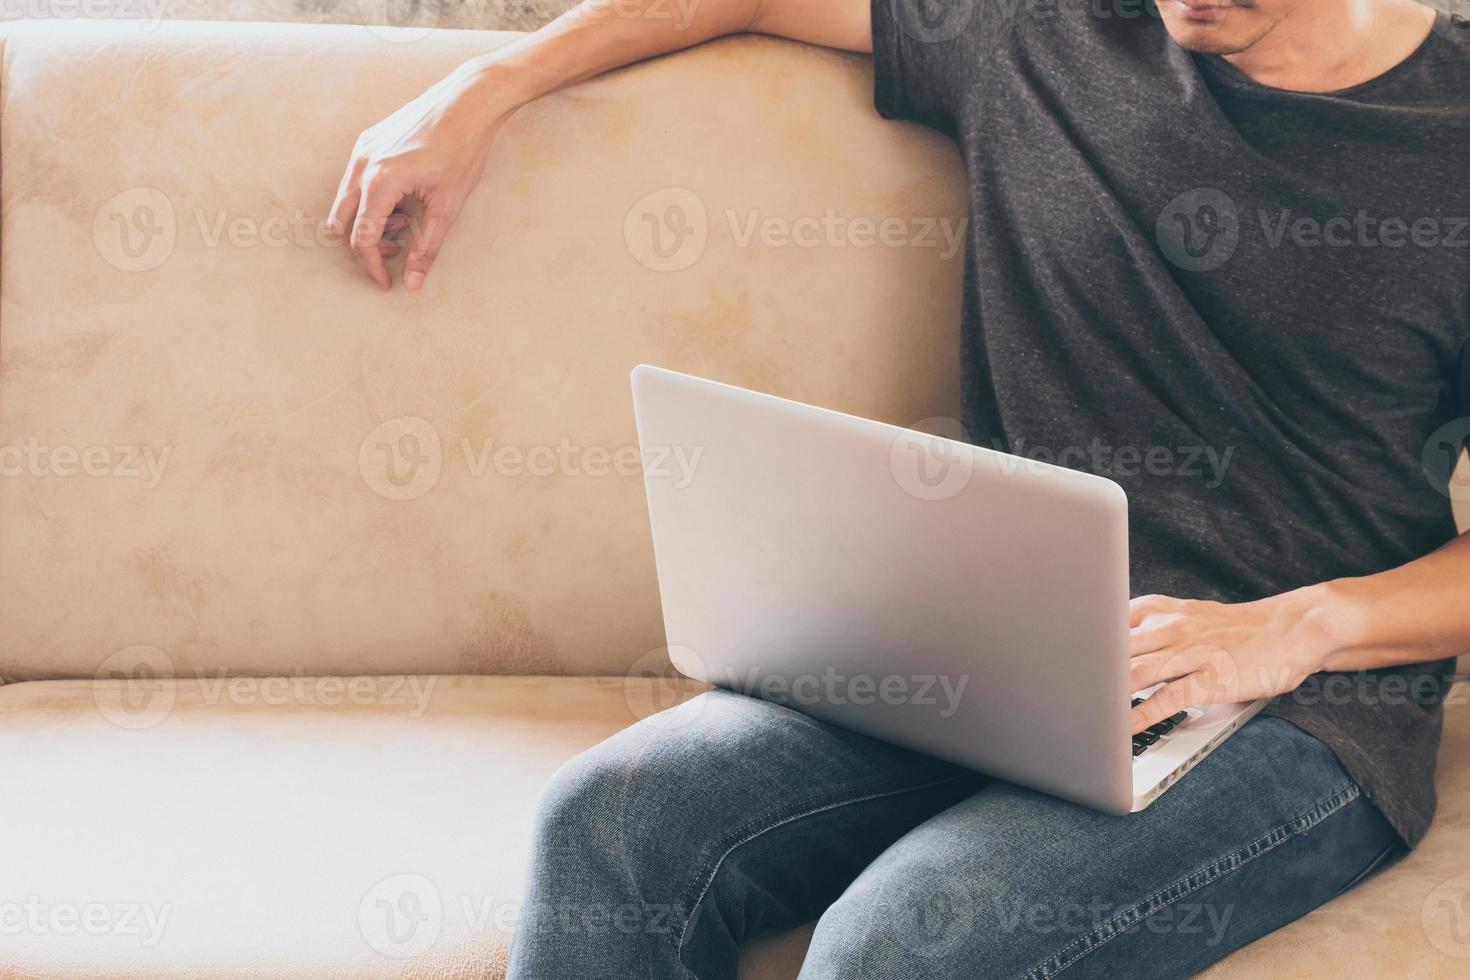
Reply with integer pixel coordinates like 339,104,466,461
0,21,963,679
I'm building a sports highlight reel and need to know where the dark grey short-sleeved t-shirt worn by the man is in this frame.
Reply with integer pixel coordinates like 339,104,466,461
873,0,1470,845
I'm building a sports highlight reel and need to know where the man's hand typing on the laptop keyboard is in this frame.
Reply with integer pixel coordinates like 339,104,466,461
1129,594,1333,733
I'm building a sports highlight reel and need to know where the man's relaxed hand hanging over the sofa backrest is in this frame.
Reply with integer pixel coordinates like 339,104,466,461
329,63,506,291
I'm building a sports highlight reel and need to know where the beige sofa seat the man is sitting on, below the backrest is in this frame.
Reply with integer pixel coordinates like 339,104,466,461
0,676,1470,980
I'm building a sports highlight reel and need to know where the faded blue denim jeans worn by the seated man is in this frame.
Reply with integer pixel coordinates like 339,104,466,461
510,691,1398,980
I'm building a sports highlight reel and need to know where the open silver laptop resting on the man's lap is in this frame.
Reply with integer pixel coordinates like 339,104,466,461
632,364,1264,814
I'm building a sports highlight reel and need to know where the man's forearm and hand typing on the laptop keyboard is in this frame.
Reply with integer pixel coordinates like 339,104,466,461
1132,532,1470,732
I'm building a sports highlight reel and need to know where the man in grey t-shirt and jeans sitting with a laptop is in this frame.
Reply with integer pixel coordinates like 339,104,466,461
332,0,1470,980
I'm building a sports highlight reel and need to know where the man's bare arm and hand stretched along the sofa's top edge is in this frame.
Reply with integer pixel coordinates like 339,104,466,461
329,0,872,289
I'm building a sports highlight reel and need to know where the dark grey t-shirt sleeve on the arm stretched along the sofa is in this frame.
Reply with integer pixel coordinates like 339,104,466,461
872,0,1005,135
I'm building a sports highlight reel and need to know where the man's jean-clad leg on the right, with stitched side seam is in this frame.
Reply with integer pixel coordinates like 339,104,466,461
801,717,1397,980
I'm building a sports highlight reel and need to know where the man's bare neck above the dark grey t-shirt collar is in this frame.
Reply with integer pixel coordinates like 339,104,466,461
1226,0,1435,93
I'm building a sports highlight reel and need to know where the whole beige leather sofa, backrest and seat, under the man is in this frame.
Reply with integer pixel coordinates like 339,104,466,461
0,22,1470,979
